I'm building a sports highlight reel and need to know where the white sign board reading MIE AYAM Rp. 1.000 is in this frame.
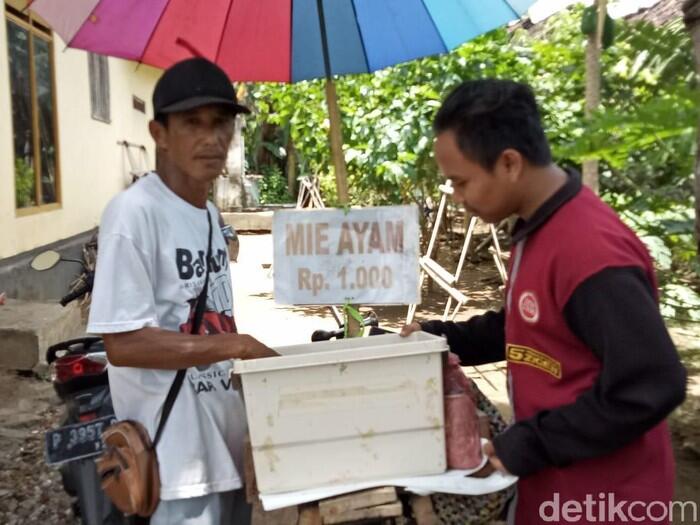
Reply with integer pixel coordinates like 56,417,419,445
272,206,420,304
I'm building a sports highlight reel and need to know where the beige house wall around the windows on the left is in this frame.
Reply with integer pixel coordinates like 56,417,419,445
0,17,160,259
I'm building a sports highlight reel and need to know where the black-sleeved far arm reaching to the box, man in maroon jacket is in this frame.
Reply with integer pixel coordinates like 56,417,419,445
412,308,506,366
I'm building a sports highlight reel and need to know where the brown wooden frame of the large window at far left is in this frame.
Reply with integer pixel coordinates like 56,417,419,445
4,4,63,217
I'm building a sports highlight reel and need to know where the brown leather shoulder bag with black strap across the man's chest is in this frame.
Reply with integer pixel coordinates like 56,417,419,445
95,211,212,518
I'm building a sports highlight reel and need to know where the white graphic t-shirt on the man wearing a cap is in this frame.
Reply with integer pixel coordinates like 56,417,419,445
88,173,247,500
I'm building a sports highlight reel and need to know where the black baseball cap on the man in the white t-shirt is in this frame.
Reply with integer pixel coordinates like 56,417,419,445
153,57,250,115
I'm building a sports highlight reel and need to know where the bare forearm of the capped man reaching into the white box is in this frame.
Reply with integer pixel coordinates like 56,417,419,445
103,328,277,370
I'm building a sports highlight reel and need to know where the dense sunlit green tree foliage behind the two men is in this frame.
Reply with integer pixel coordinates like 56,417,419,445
247,8,700,317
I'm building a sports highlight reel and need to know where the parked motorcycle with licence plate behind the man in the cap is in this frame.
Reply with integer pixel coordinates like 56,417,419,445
31,251,124,525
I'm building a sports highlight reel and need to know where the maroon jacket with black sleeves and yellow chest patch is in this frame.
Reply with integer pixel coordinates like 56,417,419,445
422,173,685,525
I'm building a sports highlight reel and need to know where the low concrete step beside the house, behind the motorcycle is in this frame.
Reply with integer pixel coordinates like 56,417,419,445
0,299,83,370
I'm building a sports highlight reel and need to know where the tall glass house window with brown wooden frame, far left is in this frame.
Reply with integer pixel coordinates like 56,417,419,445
6,6,60,212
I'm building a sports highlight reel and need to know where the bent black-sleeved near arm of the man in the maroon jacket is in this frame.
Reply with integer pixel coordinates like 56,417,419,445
493,268,686,476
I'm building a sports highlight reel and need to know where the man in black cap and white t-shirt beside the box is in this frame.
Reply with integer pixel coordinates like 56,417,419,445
88,58,275,525
